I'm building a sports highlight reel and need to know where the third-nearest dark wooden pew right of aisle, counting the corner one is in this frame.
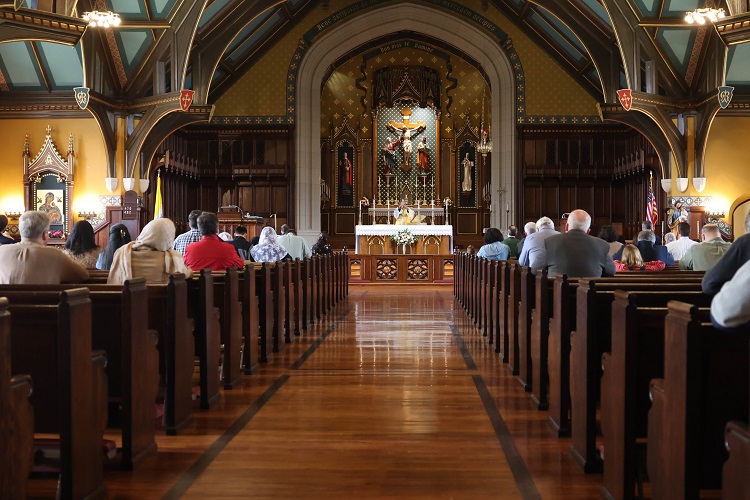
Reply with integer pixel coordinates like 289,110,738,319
601,287,711,499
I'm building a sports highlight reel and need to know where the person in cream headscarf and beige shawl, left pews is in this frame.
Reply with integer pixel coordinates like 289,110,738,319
107,218,192,285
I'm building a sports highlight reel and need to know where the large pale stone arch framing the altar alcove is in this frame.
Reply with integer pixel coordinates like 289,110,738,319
296,1,525,239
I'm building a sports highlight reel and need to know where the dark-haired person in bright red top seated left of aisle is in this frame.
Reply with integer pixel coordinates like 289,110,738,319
185,212,245,271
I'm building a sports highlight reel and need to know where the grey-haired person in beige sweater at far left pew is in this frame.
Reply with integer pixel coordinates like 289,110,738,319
0,211,89,285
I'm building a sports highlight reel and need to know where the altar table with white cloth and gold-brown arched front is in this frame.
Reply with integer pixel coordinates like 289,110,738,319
355,224,453,255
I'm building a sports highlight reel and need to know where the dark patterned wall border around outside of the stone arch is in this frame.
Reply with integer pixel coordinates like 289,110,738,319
210,0,603,125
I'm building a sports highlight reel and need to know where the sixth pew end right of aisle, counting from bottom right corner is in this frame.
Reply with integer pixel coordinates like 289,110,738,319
530,269,554,410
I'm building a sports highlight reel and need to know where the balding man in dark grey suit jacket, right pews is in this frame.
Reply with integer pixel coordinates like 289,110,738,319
533,210,615,278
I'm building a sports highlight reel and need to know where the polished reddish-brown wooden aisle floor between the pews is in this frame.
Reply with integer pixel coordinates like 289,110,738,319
29,285,601,499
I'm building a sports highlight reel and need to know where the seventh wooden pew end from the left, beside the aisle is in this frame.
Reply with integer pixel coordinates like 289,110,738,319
244,263,262,375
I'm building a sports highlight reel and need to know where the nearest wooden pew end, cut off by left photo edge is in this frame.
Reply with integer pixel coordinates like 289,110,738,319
0,298,34,500
